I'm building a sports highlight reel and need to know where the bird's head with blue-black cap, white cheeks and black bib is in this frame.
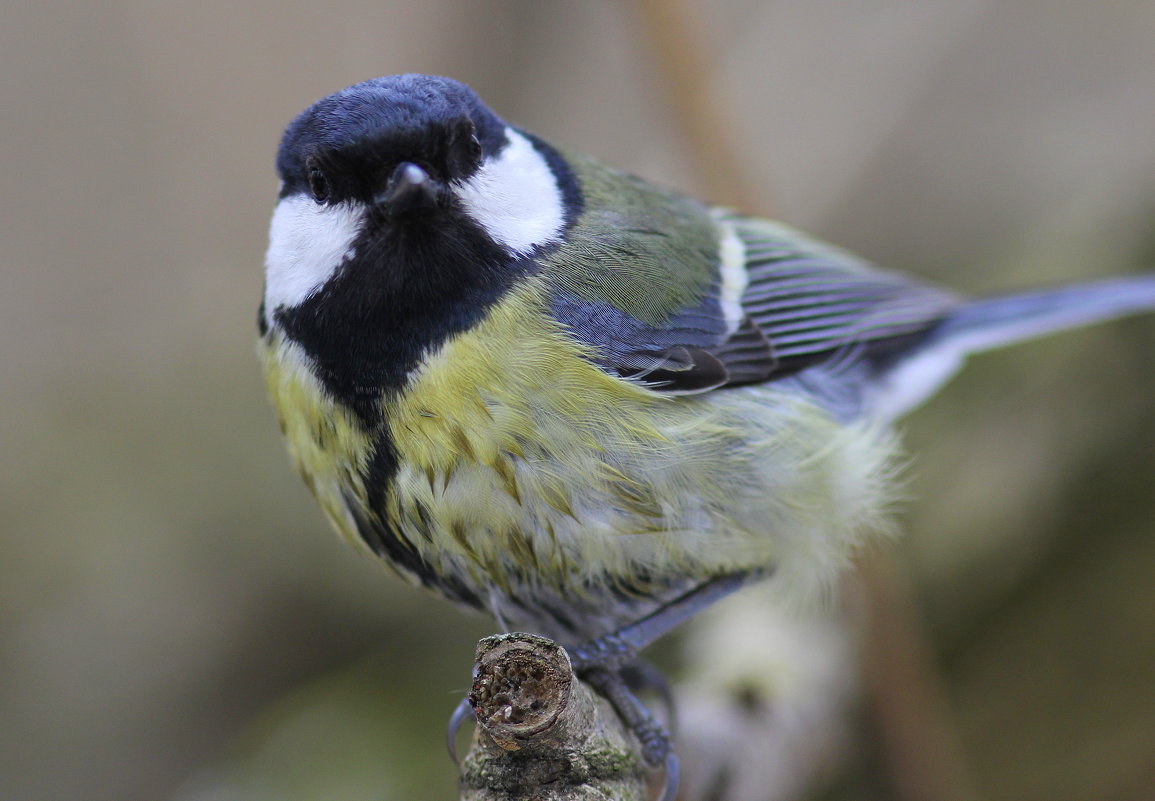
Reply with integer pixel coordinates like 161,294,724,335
259,75,581,410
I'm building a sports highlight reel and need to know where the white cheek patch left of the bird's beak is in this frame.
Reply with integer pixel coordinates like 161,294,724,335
264,195,364,314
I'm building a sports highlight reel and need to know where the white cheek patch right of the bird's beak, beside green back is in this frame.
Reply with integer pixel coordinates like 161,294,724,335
453,128,566,253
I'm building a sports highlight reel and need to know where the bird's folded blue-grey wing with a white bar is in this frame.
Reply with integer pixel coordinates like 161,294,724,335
552,217,957,394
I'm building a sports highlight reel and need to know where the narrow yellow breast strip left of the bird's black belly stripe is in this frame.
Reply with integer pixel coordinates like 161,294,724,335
259,330,372,547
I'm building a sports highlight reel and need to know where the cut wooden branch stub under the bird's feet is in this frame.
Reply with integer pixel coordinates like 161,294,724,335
461,634,649,801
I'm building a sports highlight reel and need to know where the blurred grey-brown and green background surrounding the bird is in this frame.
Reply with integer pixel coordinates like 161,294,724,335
0,0,1155,801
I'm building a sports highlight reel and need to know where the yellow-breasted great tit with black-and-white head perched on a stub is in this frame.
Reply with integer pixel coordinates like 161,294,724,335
259,68,1155,784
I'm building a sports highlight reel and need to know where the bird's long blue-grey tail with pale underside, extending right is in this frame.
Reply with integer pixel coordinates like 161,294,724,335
870,275,1155,419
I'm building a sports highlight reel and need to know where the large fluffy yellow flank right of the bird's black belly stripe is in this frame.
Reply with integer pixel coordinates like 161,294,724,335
378,279,893,609
